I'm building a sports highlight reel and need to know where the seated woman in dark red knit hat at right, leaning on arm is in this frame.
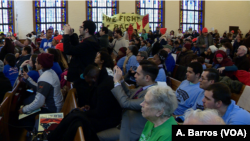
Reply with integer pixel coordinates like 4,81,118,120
212,50,238,78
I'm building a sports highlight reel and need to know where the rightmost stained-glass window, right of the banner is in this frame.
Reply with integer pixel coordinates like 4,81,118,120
180,0,204,32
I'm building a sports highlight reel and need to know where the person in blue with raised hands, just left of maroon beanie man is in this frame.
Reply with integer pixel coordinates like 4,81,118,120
20,54,40,83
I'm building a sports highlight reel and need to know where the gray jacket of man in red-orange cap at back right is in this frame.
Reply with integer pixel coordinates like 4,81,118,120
196,34,214,53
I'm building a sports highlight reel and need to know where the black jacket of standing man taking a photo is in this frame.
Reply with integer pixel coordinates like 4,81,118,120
63,34,100,82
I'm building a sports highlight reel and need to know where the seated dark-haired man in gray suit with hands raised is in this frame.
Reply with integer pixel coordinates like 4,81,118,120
97,60,159,141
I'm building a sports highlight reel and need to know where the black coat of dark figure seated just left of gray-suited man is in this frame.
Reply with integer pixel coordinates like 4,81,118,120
85,68,122,132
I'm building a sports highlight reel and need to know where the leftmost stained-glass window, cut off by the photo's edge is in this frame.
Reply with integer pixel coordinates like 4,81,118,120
0,0,14,34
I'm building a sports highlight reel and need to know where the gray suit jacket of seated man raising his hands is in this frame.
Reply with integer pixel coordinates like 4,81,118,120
111,82,157,141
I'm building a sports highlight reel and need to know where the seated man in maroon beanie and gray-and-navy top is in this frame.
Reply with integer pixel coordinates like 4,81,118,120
19,53,63,131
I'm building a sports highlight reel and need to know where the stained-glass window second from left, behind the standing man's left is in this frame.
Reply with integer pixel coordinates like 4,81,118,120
34,0,68,32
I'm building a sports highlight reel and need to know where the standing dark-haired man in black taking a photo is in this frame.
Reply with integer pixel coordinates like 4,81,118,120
63,20,100,83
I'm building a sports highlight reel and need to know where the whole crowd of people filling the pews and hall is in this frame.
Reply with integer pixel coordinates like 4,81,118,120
0,20,250,141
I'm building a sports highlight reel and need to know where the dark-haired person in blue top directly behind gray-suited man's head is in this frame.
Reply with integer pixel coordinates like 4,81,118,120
153,50,168,82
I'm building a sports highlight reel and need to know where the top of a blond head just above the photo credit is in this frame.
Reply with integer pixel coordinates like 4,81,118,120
183,109,225,125
